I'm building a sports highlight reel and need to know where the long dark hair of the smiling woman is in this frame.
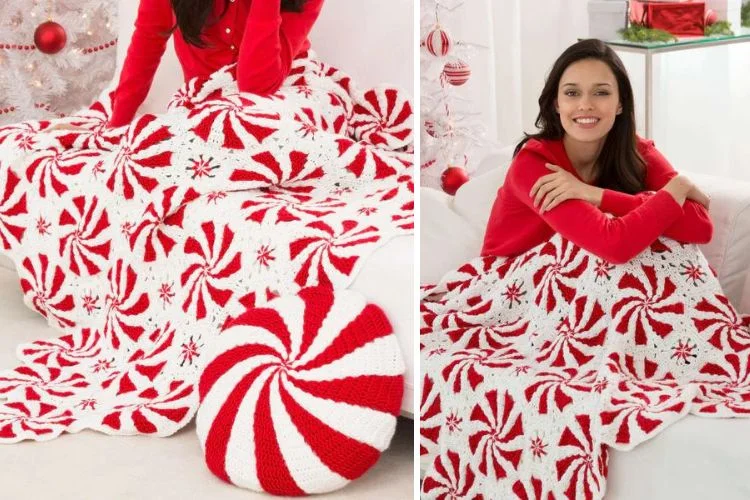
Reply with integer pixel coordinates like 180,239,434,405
514,39,646,194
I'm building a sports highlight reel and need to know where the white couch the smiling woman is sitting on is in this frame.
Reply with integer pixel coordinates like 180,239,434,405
420,150,750,500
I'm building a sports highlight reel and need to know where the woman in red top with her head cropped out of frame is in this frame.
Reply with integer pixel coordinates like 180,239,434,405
109,0,323,127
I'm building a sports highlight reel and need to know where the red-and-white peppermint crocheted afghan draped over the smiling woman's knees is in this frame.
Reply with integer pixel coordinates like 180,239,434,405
421,235,750,500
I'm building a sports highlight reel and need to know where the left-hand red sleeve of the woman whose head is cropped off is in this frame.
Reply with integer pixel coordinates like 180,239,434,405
108,0,174,127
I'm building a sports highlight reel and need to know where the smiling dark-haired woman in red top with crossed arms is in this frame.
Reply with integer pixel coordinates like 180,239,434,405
482,40,712,264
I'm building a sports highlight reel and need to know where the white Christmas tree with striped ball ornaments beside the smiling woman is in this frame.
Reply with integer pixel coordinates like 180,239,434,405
420,0,494,194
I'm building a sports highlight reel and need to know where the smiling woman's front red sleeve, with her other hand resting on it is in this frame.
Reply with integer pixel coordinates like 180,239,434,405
506,151,682,264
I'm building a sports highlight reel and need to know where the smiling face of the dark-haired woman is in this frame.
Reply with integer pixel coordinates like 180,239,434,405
555,59,622,142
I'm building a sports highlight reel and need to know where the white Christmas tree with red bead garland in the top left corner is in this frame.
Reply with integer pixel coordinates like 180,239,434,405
0,0,117,125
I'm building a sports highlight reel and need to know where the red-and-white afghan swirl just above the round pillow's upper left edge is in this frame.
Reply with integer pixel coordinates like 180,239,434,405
180,221,242,319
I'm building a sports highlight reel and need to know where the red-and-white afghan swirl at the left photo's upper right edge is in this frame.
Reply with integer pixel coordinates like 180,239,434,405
349,88,413,150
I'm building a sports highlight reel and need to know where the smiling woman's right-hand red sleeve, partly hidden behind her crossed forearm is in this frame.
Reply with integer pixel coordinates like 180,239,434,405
600,145,713,243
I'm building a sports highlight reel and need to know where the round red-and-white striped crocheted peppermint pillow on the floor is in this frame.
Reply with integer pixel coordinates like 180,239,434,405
196,287,405,496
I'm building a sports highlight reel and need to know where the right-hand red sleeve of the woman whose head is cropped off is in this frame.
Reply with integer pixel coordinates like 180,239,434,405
237,0,323,94
